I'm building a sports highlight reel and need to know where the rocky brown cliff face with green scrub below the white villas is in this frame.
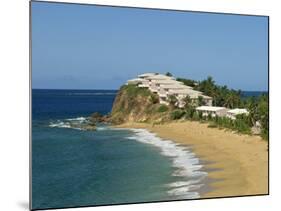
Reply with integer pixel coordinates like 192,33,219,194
110,85,170,124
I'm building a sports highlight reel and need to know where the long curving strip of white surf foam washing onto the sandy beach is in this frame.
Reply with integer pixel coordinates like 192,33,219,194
128,129,207,198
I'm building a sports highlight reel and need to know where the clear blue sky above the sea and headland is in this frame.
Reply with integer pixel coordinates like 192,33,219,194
31,2,268,91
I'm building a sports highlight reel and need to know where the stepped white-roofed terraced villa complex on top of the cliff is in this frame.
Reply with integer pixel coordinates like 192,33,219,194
127,73,212,108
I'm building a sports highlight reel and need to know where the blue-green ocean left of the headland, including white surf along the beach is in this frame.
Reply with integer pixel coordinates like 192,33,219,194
32,89,207,209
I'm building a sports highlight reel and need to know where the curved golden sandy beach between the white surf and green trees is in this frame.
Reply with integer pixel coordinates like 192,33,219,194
115,121,268,198
